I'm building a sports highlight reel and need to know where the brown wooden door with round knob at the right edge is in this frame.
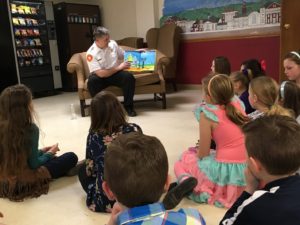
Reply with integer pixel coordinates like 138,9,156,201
280,0,300,80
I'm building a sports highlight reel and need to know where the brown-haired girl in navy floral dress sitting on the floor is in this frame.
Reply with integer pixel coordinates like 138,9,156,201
78,91,142,212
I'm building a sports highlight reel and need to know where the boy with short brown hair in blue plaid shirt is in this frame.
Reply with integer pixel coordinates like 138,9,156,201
102,132,205,225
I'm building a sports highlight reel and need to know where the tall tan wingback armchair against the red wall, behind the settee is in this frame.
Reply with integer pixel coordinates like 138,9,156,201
146,24,182,91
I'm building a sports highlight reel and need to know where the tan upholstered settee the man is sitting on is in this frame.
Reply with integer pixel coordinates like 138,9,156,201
67,46,166,116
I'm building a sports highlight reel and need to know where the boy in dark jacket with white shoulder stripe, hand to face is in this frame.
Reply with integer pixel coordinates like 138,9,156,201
220,115,300,225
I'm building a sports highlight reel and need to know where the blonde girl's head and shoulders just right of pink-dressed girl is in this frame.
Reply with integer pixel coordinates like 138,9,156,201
248,76,294,120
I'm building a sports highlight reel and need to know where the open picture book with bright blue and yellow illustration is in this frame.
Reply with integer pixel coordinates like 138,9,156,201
124,50,156,72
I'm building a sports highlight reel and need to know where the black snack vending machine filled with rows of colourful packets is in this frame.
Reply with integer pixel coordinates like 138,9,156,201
0,0,54,92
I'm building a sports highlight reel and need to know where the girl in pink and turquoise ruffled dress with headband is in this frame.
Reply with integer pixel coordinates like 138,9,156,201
174,74,249,208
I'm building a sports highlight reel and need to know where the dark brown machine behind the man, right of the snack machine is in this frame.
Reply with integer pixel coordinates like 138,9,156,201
54,2,101,91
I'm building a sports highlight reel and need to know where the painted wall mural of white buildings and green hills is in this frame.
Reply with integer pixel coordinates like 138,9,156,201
160,0,281,33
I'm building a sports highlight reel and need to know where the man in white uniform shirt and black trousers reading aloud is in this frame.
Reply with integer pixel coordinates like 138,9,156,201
86,27,136,116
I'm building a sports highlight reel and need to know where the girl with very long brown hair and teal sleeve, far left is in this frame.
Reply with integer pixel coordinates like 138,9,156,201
0,85,78,201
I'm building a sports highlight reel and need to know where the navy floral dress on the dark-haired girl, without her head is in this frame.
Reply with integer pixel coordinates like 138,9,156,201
86,123,142,212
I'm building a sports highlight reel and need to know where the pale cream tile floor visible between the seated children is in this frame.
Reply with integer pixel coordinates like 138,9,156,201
0,86,225,225
